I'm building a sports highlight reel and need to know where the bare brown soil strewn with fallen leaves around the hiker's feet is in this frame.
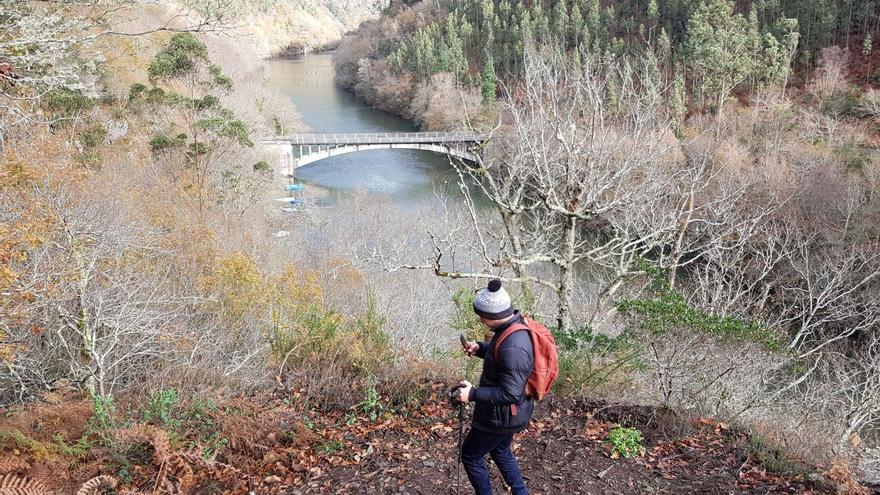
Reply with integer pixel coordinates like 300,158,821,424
286,401,837,495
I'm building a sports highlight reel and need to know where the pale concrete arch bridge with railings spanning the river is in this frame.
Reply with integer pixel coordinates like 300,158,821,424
261,132,487,176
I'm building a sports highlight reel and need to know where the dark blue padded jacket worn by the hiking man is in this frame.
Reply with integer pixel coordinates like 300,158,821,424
468,312,535,434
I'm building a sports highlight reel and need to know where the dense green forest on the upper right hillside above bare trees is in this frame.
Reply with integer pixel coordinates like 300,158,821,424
336,0,880,126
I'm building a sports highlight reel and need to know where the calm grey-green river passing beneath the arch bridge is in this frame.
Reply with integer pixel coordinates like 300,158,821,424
266,53,454,206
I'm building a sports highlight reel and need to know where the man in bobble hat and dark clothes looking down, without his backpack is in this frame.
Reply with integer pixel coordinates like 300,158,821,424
458,280,535,495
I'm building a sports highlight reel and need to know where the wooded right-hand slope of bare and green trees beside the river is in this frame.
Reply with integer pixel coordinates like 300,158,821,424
335,0,880,479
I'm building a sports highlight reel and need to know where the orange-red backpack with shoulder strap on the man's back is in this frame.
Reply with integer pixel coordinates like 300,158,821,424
492,316,559,404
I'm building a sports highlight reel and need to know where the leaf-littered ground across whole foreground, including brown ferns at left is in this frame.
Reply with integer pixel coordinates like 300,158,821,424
0,397,867,495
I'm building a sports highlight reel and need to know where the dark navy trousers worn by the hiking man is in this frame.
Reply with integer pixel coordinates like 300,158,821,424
461,428,529,495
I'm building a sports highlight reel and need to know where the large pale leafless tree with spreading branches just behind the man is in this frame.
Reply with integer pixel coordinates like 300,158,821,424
372,48,712,331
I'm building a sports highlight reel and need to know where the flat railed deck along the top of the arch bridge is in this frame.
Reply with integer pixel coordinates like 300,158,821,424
264,132,487,145
